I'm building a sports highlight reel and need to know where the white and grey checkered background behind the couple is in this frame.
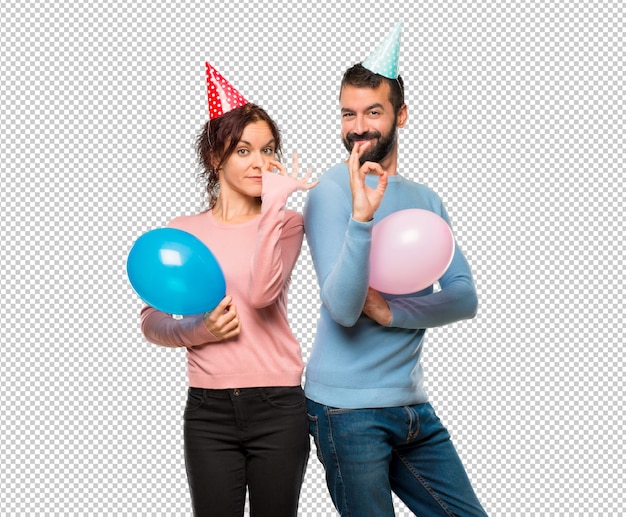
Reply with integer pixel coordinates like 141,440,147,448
0,0,626,517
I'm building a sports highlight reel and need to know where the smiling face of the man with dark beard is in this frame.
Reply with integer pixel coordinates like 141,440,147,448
339,82,397,164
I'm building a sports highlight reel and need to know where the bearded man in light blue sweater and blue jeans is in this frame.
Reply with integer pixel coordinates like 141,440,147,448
305,22,486,517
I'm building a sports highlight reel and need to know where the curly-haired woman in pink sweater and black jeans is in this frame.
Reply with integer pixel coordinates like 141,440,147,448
141,69,316,517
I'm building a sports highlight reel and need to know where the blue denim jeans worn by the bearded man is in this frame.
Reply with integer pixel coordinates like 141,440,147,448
307,400,487,517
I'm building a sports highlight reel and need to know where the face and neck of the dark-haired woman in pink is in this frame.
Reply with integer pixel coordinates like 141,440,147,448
219,121,276,202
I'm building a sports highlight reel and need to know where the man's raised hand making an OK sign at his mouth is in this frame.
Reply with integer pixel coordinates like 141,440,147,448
348,142,388,222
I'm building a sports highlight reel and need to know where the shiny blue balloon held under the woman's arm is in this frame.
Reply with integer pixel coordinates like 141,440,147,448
126,228,226,316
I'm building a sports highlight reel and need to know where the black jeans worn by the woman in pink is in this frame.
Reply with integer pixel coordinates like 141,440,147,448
185,386,310,517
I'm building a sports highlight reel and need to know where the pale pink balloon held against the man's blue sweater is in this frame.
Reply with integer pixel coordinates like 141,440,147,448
370,208,454,294
